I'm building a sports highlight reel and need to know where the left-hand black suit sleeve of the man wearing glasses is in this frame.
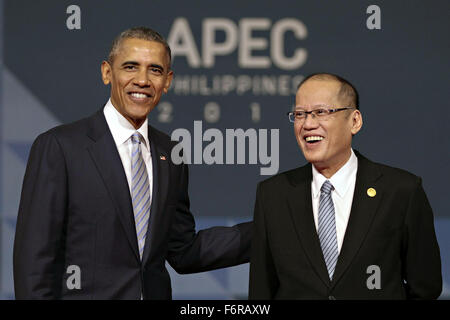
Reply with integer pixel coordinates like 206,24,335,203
249,184,278,300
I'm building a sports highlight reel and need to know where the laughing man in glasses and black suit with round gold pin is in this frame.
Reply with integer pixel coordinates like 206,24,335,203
249,74,442,300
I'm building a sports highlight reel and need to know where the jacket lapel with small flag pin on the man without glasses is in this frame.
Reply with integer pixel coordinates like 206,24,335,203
142,126,170,264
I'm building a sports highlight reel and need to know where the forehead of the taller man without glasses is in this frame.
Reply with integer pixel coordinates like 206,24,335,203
114,38,168,66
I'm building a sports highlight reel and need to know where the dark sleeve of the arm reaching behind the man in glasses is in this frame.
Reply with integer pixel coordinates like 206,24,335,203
168,164,253,273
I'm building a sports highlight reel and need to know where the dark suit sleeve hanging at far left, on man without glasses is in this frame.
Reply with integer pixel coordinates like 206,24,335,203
13,132,67,299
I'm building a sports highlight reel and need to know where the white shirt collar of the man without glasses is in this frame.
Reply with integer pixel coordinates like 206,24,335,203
103,99,150,148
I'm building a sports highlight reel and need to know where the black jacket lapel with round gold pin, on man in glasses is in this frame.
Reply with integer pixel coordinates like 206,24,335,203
332,151,383,287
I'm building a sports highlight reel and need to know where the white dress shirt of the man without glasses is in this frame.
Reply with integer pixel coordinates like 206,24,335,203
103,99,153,205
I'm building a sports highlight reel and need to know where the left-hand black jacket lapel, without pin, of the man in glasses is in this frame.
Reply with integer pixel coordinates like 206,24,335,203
287,164,330,287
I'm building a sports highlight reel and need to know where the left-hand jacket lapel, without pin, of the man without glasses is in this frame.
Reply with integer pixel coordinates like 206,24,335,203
87,108,139,259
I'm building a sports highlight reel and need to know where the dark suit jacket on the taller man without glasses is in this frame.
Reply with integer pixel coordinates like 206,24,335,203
14,109,251,299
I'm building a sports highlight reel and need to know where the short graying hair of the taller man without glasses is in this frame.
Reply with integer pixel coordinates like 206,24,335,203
108,27,172,69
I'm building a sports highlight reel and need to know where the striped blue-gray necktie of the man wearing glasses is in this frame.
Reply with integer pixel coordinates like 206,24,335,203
319,180,339,280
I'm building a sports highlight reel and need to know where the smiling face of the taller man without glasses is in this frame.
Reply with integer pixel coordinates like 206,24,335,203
102,37,173,129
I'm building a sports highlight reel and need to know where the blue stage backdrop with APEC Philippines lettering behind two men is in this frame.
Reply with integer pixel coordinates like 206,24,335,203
0,0,450,299
